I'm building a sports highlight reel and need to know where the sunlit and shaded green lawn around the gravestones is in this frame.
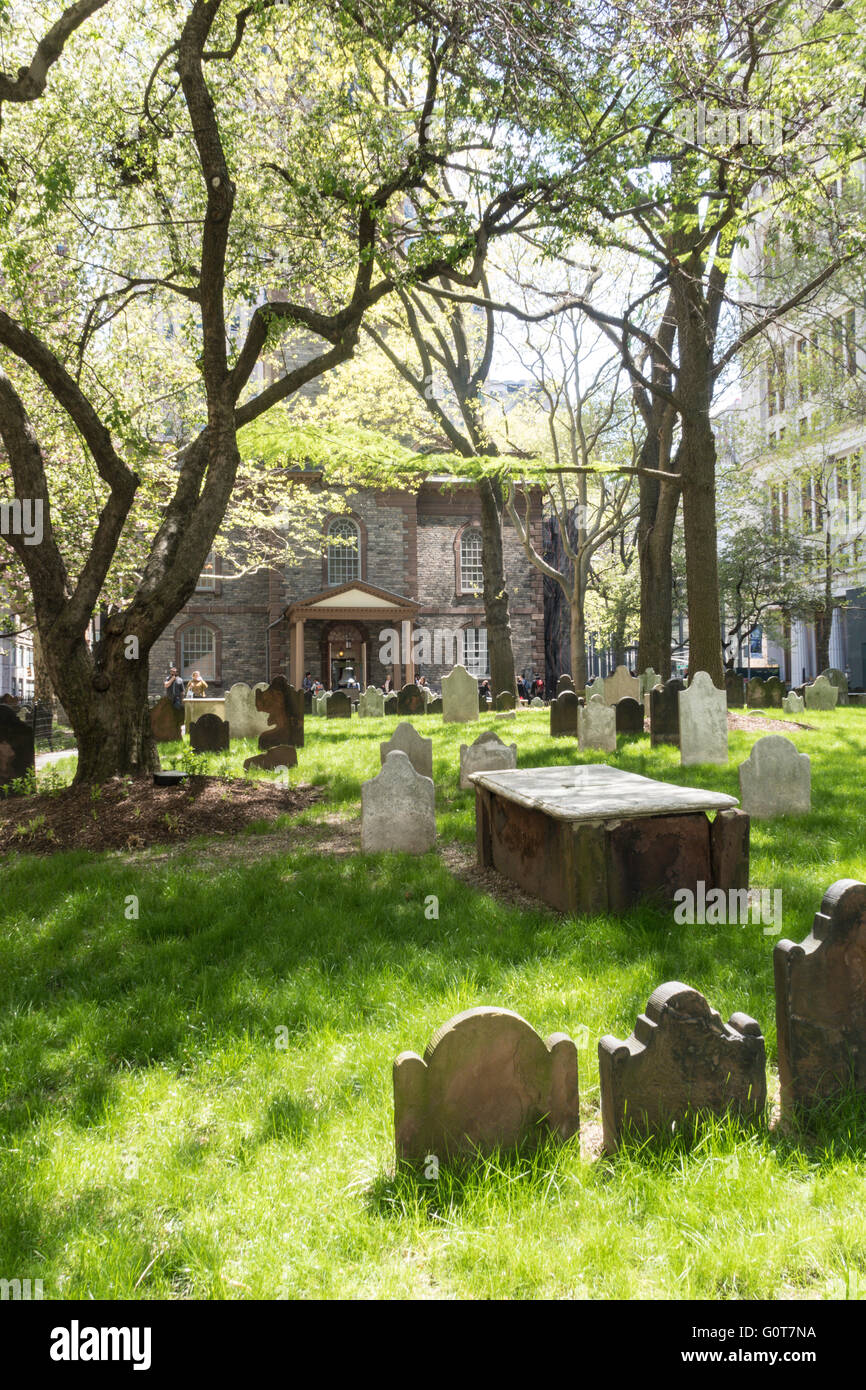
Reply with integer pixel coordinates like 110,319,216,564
0,709,866,1298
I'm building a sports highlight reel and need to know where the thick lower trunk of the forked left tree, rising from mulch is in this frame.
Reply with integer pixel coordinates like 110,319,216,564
43,631,160,784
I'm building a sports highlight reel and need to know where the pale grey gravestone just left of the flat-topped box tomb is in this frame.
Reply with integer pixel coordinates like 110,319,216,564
361,749,436,855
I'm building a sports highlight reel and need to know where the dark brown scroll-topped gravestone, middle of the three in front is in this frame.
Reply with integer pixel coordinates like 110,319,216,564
598,978,767,1154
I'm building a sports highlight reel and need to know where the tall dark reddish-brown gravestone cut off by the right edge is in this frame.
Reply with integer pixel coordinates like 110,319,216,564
773,878,866,1111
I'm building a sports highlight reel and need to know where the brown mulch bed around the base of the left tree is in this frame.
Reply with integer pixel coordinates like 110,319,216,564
0,777,322,853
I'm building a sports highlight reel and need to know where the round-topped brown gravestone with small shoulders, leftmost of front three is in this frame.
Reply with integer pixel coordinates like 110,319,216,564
393,1006,580,1163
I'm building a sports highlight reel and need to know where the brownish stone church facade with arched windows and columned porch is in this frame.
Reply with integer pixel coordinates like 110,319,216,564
150,474,545,698
